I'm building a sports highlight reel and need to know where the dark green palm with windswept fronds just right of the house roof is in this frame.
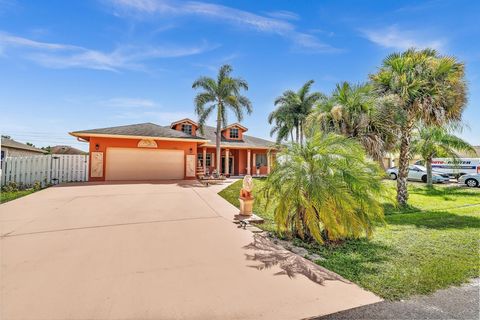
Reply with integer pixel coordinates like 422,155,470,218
268,80,324,144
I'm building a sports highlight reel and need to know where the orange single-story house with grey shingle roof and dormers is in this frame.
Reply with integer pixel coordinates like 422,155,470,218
70,119,274,181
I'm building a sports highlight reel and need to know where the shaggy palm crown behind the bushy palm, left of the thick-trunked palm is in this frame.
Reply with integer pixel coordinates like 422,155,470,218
308,82,397,166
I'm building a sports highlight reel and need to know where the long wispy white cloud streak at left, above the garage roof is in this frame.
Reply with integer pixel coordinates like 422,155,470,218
0,32,217,71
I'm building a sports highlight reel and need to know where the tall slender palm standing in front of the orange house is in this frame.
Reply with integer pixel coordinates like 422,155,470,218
192,64,252,173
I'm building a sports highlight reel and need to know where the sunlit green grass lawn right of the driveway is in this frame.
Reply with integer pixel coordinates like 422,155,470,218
220,179,480,300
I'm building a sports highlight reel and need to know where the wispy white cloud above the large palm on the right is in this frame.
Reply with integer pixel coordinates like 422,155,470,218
361,25,446,50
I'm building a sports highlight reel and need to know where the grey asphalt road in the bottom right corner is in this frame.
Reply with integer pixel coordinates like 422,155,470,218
317,279,480,320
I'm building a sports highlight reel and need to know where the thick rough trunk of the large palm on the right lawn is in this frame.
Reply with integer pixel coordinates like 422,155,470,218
397,115,414,206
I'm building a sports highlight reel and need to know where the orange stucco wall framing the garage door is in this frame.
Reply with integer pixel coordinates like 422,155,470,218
88,137,197,181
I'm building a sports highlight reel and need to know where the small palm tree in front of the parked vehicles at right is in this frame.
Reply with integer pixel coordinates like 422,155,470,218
412,127,475,187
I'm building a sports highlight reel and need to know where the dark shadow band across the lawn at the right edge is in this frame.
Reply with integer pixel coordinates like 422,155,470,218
385,211,480,229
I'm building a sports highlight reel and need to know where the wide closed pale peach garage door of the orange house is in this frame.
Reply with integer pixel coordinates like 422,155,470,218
105,148,185,180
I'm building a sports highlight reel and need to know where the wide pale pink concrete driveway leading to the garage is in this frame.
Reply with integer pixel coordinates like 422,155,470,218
0,182,380,320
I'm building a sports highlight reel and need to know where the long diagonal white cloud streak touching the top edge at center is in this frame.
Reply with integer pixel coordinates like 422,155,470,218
103,0,338,52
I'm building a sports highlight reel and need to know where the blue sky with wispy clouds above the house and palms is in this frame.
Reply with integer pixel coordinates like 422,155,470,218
0,0,480,149
